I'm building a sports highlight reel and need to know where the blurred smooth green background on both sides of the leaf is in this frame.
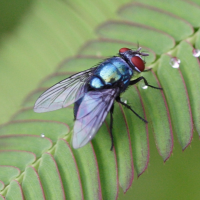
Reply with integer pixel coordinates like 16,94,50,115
0,0,200,200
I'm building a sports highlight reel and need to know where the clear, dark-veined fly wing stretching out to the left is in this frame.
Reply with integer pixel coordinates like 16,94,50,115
34,68,96,113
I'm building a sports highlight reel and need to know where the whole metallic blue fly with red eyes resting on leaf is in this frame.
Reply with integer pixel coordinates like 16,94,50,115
34,47,162,150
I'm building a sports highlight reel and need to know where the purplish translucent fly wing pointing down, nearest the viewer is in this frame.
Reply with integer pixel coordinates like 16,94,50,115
73,88,119,149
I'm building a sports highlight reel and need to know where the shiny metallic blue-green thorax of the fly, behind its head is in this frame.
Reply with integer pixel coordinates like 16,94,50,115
89,57,133,90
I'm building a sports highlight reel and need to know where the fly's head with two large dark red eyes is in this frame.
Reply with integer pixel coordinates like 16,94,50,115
119,47,149,72
